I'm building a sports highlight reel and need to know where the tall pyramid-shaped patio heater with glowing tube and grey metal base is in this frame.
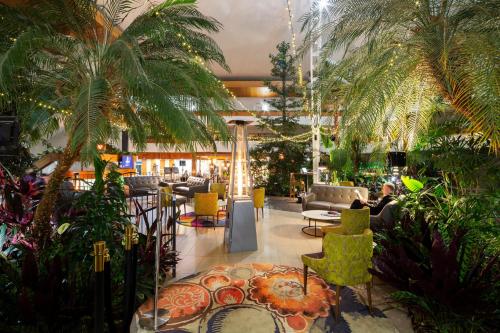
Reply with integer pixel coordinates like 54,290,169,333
224,120,257,252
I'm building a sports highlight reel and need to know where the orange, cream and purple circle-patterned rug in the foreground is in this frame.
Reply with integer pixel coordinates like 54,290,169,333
131,263,397,333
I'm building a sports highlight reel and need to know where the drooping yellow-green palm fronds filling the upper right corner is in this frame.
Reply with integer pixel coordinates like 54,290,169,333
304,0,500,149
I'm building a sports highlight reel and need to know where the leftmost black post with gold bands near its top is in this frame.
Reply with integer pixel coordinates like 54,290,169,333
94,241,106,333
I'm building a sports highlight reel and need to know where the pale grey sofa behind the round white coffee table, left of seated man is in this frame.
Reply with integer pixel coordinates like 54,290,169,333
302,184,368,210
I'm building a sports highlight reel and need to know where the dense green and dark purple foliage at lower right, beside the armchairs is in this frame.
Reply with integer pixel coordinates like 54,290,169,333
372,179,500,332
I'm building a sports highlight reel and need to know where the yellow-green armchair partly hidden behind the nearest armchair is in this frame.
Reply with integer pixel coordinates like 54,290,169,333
321,207,370,235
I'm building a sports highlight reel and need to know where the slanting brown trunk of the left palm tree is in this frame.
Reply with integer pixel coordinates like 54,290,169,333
33,141,80,244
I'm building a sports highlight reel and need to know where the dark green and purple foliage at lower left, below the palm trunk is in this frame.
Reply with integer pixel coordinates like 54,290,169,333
0,160,177,332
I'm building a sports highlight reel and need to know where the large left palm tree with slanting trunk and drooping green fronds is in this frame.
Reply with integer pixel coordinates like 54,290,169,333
0,0,229,242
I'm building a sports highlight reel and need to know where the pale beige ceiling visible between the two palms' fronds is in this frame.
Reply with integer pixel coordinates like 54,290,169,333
121,0,311,80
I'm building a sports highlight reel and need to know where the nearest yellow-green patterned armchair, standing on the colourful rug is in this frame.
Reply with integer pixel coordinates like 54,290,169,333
302,229,373,319
